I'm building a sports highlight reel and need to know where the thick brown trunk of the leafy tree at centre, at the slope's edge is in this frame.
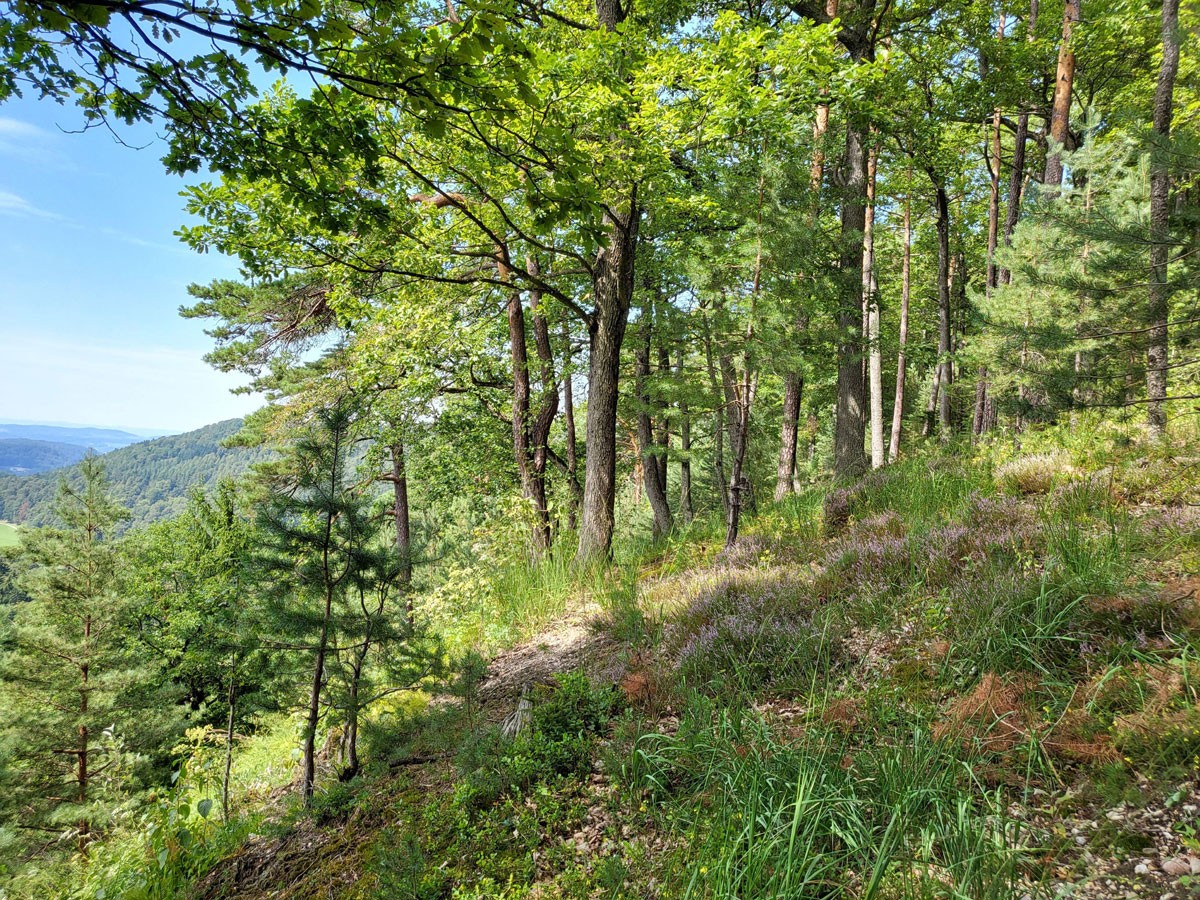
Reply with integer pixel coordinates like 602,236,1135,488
576,196,641,565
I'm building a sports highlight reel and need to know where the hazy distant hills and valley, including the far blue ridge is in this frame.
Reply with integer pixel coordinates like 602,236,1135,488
0,419,271,532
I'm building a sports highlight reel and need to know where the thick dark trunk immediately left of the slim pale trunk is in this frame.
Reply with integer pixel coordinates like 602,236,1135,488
833,120,866,476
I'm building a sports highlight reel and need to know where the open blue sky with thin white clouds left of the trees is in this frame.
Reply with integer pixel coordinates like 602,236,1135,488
0,98,260,432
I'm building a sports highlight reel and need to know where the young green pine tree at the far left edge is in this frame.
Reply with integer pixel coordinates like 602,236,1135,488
0,456,178,853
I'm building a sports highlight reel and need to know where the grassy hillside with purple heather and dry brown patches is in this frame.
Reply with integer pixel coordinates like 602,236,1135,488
23,427,1200,898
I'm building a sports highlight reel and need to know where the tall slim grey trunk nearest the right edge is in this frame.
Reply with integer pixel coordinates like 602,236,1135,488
1146,0,1180,438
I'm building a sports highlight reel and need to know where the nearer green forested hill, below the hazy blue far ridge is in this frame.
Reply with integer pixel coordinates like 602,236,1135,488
0,419,271,526
